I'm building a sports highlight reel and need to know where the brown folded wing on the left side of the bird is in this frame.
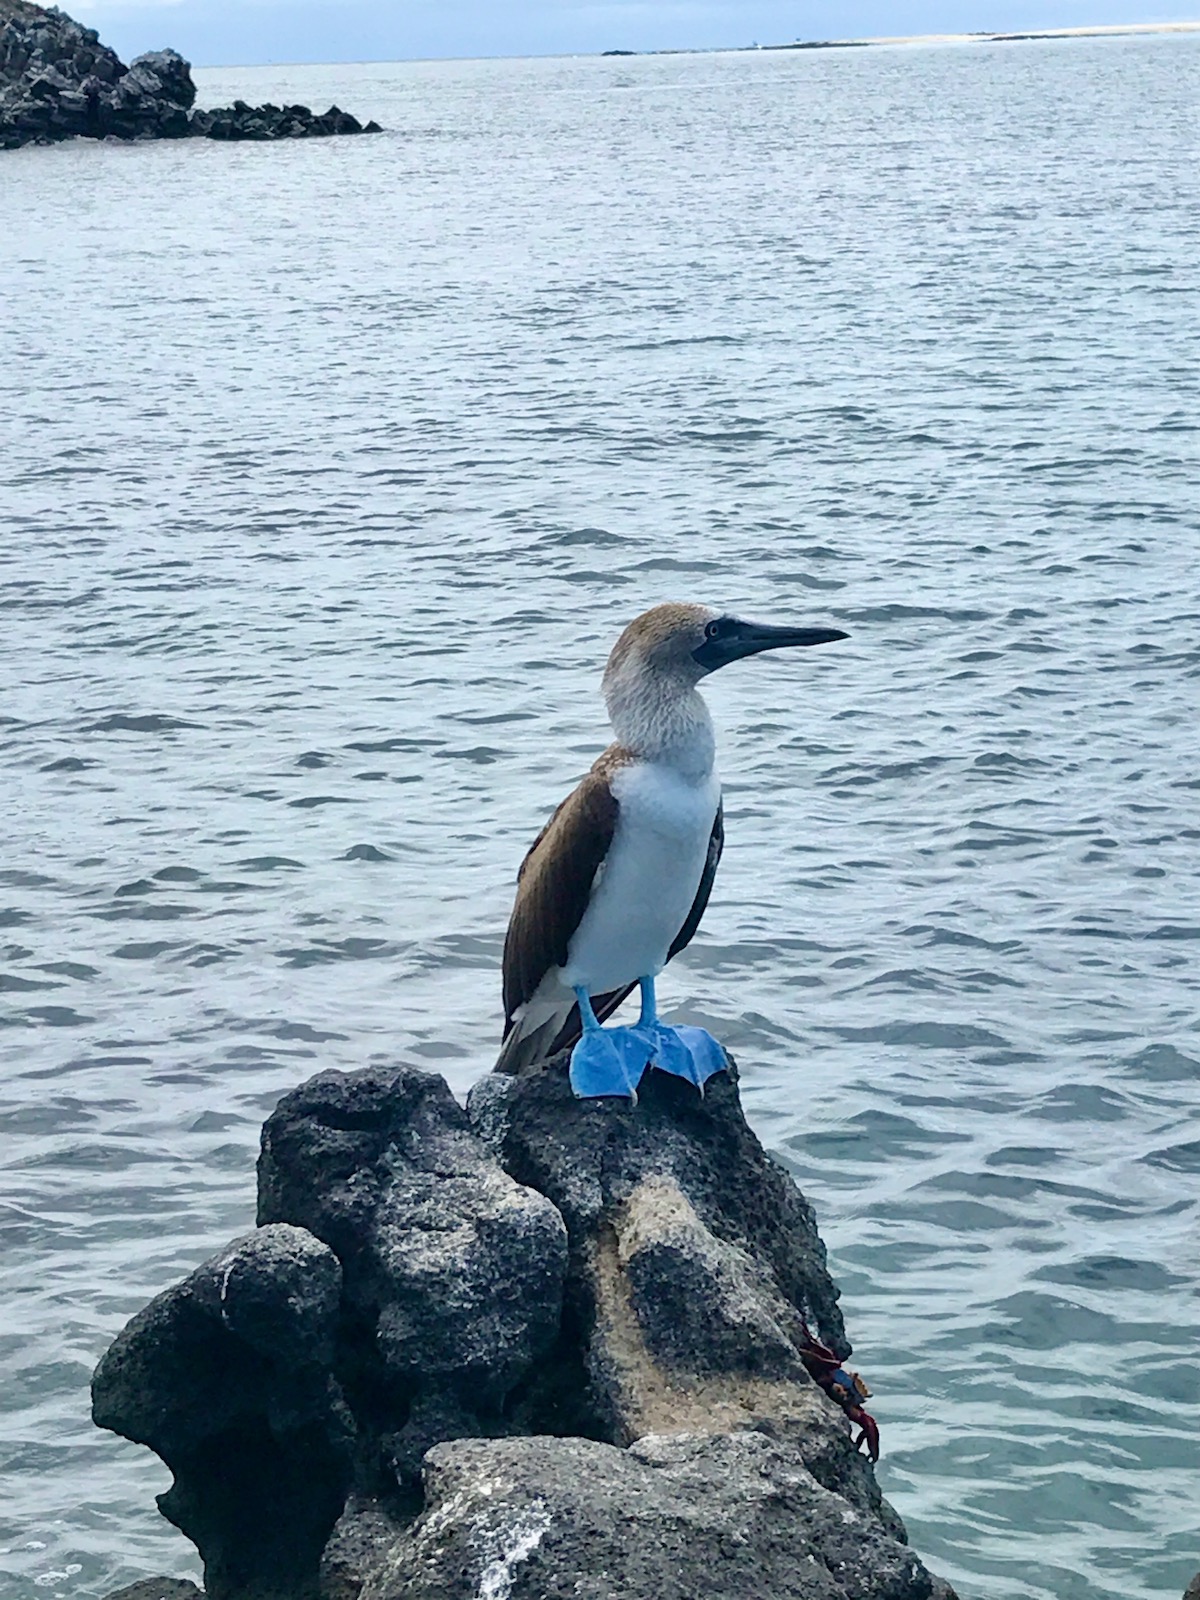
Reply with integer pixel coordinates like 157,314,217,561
504,768,621,1034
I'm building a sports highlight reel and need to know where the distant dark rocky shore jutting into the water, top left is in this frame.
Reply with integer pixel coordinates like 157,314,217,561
0,0,381,150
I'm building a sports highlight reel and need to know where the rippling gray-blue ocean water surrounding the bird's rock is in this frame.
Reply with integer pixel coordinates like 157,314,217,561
0,37,1200,1600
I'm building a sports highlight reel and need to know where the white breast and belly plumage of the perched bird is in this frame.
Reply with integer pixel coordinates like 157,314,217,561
562,762,720,994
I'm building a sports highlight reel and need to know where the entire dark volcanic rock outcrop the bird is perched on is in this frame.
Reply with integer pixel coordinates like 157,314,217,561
93,1058,950,1600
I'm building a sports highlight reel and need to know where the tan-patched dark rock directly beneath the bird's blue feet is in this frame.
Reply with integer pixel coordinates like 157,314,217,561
467,1058,876,1528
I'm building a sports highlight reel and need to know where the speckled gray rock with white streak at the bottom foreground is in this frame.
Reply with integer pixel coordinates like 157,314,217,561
358,1432,933,1600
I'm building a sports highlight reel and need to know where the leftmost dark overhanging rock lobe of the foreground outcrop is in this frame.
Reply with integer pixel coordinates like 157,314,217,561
93,1227,355,1600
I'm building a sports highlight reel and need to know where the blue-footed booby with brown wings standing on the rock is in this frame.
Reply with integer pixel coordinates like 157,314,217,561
496,605,846,1099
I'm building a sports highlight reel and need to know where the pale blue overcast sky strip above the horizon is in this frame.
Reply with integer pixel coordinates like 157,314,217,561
72,0,1200,66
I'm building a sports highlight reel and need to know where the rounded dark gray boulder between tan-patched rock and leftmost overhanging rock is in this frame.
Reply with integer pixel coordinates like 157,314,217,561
259,1067,566,1490
